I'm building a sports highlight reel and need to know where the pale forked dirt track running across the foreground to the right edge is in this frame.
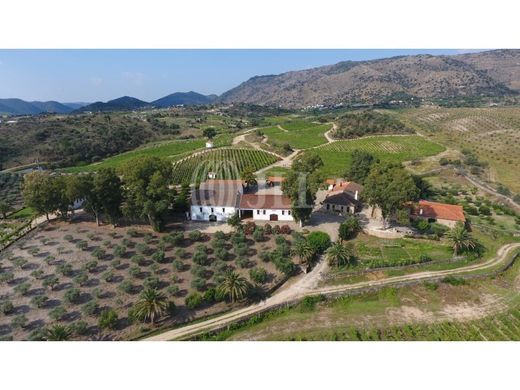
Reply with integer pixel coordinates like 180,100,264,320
145,243,520,341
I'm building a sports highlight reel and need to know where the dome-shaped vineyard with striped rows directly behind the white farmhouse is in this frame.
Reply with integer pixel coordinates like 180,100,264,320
173,148,278,184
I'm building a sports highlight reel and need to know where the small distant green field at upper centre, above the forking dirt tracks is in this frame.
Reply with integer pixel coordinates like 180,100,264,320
262,120,331,149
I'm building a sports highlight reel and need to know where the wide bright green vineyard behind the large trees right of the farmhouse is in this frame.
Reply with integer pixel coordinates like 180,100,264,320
314,135,445,177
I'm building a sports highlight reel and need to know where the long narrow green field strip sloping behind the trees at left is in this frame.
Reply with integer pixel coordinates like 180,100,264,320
64,134,233,173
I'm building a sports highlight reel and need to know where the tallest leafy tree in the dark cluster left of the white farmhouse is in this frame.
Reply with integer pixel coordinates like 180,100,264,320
121,157,174,231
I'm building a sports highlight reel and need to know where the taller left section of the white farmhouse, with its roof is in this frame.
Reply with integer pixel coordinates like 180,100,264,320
190,180,244,222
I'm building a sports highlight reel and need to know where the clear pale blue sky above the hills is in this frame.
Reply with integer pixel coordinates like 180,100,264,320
0,49,486,103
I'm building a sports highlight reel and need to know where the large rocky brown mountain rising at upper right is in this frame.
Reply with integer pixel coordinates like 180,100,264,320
218,50,520,108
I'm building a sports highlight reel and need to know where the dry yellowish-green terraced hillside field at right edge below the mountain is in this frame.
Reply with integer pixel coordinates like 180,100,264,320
402,107,520,193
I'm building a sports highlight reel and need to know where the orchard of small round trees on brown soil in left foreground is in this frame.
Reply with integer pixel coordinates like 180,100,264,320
0,215,292,340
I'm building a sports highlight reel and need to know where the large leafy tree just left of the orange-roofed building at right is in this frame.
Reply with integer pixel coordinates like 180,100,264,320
363,163,419,226
